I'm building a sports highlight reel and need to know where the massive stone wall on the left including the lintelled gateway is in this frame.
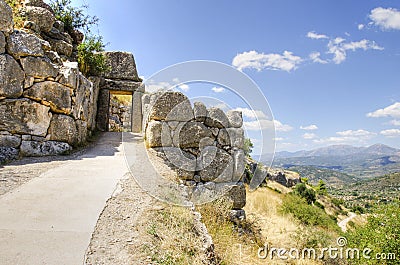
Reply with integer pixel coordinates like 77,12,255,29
0,0,142,163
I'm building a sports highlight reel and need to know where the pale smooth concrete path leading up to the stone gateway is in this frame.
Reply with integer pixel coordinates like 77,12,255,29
0,133,128,265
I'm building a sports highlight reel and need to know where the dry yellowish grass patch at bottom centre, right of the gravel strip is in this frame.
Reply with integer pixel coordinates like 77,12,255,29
142,205,205,265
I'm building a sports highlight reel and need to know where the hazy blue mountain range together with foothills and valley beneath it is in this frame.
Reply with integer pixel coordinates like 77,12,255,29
270,144,400,180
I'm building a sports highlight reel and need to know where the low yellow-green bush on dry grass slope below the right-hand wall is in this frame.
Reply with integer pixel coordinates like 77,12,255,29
281,194,338,230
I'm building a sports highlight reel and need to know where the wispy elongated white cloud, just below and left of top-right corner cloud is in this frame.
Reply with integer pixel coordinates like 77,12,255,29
327,37,383,64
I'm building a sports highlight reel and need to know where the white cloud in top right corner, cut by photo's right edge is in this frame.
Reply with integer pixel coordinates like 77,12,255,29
369,7,400,30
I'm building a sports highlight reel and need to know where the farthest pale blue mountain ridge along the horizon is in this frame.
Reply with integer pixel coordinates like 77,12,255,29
275,144,400,158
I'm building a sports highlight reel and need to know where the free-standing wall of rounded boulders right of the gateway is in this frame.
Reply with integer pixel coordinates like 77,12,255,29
142,91,246,209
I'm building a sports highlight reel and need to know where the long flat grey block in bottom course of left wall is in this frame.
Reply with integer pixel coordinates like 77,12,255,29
20,141,72,156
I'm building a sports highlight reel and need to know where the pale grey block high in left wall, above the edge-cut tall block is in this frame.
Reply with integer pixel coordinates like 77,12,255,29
7,30,44,59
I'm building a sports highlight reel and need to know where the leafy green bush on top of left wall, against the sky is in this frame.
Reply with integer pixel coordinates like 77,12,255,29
50,0,99,32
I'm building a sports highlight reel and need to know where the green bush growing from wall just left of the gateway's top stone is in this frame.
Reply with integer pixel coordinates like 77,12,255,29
78,35,108,76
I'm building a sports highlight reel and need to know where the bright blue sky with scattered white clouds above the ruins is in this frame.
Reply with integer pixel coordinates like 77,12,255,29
69,0,400,151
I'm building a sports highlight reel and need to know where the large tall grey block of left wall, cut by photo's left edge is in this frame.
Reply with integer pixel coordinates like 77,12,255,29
0,54,25,98
